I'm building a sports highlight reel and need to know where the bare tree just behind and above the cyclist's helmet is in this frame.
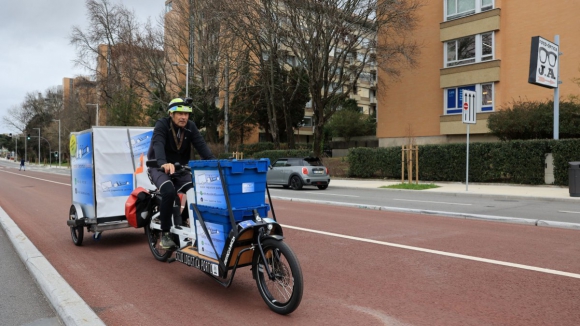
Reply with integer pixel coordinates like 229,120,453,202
165,0,243,142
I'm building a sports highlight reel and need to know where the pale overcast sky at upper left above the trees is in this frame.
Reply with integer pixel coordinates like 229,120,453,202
0,0,165,134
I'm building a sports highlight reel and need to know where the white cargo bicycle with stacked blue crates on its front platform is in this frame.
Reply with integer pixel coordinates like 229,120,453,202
142,159,303,315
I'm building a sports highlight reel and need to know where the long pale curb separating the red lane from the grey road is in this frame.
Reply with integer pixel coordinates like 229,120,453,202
272,196,580,230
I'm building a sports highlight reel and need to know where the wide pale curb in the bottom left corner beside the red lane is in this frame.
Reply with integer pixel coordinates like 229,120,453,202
0,207,105,326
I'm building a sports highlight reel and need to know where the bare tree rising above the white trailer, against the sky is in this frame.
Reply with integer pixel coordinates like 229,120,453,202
70,0,167,125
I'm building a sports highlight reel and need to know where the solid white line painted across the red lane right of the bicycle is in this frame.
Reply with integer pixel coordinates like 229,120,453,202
281,224,580,279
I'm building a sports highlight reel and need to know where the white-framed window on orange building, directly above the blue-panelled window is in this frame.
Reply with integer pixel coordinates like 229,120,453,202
444,32,494,67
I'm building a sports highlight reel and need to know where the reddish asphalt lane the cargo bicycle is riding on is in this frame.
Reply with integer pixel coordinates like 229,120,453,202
0,170,580,325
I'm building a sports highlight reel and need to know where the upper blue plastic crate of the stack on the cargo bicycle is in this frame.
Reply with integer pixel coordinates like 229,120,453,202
189,158,270,209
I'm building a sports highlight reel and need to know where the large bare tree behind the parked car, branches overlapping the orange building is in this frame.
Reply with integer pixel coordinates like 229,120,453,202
279,0,420,155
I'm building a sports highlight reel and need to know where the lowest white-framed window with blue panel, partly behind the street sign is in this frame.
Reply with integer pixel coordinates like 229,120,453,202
444,83,494,114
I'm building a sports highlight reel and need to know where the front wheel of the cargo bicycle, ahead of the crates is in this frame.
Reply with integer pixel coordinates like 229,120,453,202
252,239,304,315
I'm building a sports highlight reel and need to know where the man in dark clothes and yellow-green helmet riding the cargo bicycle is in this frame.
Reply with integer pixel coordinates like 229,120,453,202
147,98,215,249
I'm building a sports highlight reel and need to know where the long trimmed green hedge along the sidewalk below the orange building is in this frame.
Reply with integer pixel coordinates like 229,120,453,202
347,139,580,185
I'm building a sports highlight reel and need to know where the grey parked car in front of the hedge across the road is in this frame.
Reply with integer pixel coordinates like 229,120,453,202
266,157,330,190
